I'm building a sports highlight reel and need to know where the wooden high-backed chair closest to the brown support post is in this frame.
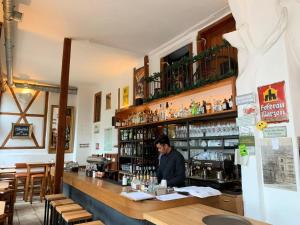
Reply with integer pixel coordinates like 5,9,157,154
25,163,47,204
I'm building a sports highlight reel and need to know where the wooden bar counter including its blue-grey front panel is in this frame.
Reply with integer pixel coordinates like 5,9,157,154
63,172,218,225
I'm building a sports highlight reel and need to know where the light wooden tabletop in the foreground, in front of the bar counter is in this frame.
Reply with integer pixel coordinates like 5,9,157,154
144,204,268,225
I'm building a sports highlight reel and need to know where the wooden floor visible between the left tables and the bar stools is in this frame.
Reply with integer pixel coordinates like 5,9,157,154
14,200,45,225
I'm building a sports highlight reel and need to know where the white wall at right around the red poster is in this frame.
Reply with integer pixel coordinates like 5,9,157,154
226,0,300,225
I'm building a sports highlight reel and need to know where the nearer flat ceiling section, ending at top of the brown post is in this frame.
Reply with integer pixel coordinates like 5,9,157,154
16,0,227,54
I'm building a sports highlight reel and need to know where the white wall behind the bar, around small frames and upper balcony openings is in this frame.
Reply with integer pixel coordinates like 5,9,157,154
93,8,230,154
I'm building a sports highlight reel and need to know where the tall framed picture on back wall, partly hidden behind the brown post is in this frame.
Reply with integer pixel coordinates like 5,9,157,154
48,105,75,153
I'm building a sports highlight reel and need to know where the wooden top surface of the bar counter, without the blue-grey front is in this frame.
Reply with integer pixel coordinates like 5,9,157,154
63,172,218,219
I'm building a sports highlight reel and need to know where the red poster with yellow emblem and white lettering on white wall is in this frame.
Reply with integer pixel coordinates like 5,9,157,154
258,81,289,123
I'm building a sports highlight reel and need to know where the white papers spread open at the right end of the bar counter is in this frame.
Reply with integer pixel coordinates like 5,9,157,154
174,186,222,198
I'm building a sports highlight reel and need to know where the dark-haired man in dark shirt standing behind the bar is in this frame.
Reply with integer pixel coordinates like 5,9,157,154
155,135,185,187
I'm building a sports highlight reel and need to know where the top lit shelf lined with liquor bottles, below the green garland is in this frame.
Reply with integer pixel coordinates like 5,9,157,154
116,79,236,128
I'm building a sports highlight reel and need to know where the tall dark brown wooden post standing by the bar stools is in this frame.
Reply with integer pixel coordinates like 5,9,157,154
54,38,71,194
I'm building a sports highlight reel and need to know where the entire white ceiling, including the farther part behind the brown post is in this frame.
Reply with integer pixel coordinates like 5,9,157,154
0,0,227,85
